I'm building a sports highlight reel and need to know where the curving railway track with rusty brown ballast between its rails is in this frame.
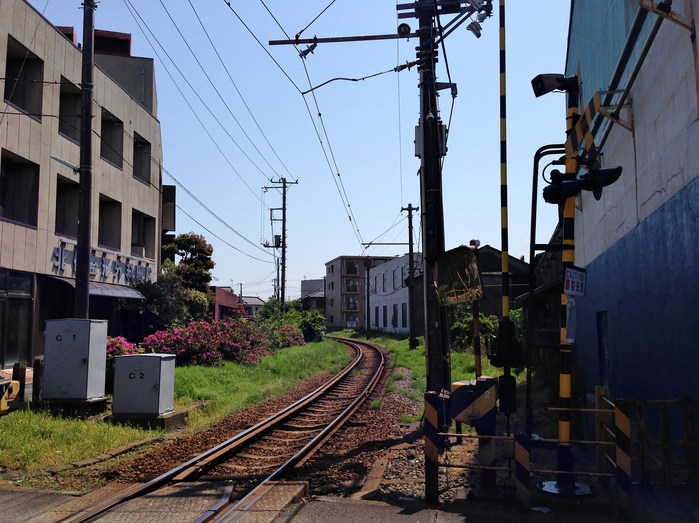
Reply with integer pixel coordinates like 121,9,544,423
61,338,385,523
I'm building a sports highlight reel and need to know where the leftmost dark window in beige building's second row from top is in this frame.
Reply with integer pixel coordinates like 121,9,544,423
0,149,39,227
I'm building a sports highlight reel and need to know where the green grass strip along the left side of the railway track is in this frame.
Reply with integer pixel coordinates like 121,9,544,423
0,340,350,470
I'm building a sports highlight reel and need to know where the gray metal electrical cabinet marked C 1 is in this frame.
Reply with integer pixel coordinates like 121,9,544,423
42,318,107,401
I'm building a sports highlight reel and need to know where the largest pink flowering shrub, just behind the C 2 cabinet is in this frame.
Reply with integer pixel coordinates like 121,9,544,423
143,318,269,367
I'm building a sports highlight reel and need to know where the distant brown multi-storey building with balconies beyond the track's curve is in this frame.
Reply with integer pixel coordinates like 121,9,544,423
325,256,393,331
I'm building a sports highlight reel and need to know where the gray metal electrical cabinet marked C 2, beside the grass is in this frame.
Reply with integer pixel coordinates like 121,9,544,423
112,354,175,416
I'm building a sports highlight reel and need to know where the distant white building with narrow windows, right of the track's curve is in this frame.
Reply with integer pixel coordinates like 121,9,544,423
369,253,424,335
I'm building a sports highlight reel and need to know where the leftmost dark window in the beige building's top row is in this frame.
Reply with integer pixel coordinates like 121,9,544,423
5,36,44,120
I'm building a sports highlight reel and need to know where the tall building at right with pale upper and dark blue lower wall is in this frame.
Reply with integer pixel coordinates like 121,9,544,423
564,0,699,399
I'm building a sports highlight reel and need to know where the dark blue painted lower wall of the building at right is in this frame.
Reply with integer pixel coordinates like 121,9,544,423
576,178,699,399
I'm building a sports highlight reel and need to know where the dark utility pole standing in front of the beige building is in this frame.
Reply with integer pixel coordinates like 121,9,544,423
75,0,97,319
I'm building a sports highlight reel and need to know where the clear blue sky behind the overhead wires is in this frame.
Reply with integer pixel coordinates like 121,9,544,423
32,0,570,299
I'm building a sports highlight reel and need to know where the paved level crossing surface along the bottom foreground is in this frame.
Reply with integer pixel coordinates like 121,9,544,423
0,482,699,523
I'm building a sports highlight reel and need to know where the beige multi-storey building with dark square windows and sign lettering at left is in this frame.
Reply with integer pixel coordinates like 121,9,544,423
0,0,174,368
